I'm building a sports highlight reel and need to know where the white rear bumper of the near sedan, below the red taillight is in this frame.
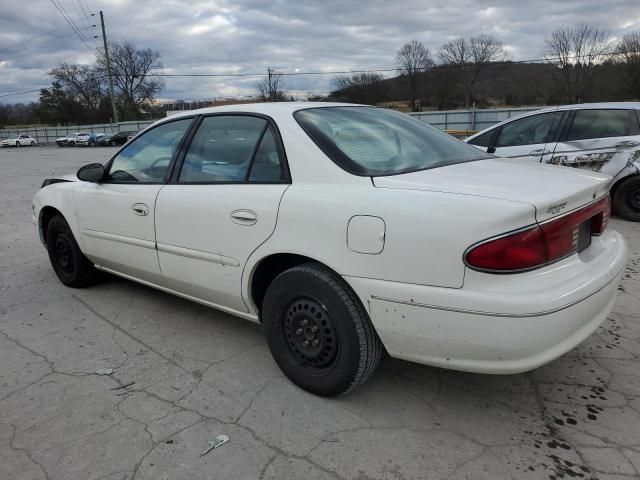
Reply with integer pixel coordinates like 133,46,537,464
345,231,627,374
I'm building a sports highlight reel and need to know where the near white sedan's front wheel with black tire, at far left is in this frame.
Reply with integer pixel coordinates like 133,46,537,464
47,215,97,288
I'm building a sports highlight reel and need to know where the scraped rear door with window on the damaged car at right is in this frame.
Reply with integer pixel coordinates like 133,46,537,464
549,108,640,176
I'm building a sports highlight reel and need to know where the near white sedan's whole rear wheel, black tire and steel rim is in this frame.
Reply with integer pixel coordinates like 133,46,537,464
262,263,383,397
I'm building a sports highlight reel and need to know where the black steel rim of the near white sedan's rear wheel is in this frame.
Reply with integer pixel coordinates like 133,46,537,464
283,298,338,370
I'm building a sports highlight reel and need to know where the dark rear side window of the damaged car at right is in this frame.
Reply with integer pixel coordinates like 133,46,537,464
567,109,640,141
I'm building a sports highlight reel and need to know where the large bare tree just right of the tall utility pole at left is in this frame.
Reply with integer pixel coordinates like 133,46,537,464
97,42,164,116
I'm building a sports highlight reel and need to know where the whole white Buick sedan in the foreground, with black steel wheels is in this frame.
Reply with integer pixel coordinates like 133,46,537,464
33,103,627,396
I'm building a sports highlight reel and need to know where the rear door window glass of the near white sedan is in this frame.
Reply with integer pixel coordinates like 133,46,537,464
178,115,286,183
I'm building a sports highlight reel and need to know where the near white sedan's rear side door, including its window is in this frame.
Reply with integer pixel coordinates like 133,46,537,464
156,114,290,312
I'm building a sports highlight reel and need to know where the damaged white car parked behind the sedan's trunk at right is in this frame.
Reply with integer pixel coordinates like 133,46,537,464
465,102,640,222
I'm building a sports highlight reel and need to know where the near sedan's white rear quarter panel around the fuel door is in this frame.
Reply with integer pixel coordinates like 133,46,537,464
244,184,535,310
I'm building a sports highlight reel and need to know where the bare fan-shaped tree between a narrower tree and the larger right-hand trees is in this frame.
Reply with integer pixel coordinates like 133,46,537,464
438,35,507,107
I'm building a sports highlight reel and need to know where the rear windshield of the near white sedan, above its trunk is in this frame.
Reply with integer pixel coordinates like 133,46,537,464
294,107,491,176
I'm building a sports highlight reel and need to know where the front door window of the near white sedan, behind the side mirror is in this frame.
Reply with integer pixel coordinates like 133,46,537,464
108,118,193,183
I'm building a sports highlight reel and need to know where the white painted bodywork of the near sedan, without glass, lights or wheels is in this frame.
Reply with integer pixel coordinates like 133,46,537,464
33,103,627,373
